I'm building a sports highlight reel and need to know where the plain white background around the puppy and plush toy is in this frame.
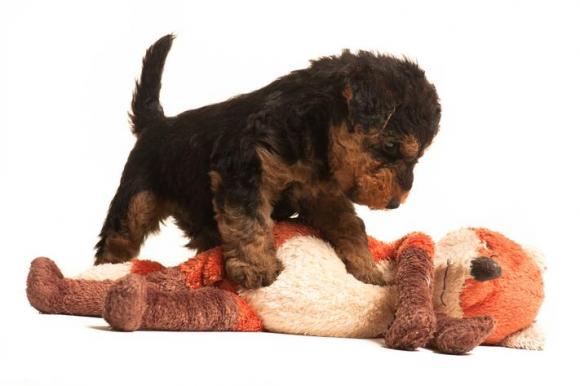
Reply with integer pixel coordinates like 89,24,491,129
0,0,580,385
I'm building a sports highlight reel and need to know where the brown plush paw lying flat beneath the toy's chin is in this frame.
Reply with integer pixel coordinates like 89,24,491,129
427,313,495,354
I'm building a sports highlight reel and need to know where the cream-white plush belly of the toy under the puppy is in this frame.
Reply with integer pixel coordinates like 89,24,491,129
240,236,393,338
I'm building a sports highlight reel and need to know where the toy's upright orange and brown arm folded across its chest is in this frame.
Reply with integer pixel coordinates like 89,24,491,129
385,233,435,350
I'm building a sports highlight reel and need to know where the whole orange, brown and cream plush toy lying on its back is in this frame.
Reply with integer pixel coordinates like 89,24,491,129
27,222,543,354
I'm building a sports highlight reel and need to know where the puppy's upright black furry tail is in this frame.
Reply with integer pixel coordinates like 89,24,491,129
129,34,175,136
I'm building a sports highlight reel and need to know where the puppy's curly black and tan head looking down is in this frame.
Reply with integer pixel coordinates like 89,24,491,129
329,51,441,209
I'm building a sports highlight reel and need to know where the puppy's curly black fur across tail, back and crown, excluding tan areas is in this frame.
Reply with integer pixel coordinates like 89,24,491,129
96,35,440,286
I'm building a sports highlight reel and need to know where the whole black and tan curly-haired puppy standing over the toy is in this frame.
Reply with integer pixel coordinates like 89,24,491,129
96,35,440,288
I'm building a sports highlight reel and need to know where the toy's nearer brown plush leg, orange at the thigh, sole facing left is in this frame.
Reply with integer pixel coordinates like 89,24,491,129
103,268,261,331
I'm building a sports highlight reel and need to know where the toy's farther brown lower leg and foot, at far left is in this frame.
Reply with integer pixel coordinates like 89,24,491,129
26,257,113,316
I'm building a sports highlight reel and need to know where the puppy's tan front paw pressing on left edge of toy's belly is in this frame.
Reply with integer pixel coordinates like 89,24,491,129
226,257,282,288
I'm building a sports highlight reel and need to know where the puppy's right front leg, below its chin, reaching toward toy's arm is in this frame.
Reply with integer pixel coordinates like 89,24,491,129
304,192,385,285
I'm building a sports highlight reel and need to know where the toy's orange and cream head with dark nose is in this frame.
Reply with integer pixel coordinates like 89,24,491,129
433,228,544,349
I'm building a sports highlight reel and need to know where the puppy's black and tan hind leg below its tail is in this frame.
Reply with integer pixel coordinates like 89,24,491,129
95,182,167,264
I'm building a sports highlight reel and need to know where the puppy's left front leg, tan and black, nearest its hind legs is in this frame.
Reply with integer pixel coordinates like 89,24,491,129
212,173,282,288
